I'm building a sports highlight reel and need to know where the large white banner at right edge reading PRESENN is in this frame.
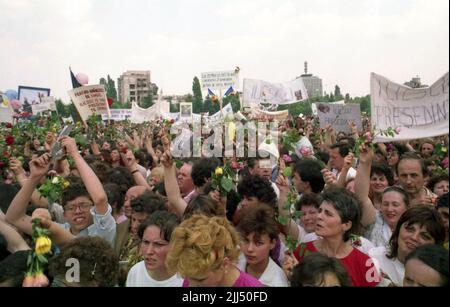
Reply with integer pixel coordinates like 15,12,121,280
370,72,449,142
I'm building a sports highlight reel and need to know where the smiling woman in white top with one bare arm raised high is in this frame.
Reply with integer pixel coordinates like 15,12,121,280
355,145,409,246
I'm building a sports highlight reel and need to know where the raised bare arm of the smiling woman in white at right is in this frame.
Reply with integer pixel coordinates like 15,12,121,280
355,145,376,227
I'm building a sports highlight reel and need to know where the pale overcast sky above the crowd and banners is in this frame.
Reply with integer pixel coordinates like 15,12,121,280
0,0,449,101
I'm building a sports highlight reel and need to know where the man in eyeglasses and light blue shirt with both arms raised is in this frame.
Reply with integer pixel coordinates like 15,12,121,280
6,136,116,244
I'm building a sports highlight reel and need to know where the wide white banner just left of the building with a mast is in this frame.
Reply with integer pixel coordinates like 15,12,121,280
243,78,308,107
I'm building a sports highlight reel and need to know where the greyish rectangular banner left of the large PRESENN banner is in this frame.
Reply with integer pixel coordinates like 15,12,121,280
316,102,362,133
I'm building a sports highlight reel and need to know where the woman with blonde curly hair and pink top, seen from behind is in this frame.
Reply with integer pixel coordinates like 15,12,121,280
166,214,262,287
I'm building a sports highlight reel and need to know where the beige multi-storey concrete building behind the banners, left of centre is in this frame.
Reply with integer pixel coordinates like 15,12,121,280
117,70,152,104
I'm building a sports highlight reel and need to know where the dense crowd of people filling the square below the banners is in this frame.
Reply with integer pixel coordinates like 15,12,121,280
0,115,449,287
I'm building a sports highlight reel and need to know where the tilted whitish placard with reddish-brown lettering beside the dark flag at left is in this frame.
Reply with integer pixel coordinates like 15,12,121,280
68,85,110,121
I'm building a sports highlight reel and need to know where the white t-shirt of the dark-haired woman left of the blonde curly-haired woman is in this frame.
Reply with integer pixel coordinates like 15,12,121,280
126,261,183,287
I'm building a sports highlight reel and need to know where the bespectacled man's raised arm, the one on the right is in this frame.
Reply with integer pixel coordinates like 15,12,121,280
60,136,108,215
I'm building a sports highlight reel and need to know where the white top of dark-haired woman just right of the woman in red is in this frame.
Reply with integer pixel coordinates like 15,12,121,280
369,246,405,287
